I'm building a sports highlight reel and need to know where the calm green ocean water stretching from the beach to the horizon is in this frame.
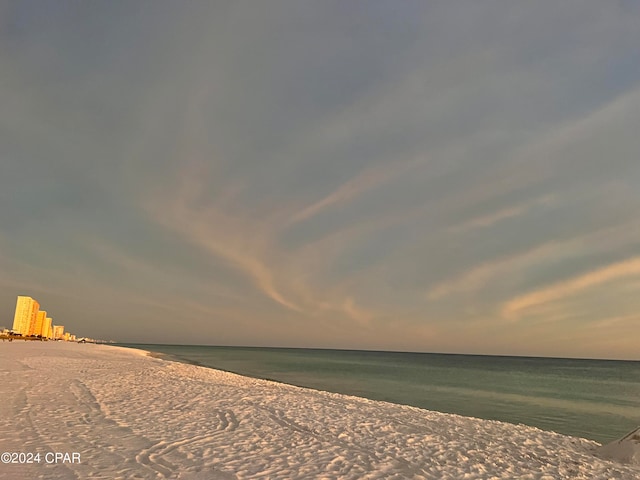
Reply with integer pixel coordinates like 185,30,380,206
123,344,640,443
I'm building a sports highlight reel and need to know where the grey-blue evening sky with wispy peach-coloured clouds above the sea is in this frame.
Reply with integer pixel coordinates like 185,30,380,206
0,0,640,359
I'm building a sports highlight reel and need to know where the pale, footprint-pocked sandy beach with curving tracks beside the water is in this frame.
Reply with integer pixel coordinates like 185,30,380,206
0,342,640,480
